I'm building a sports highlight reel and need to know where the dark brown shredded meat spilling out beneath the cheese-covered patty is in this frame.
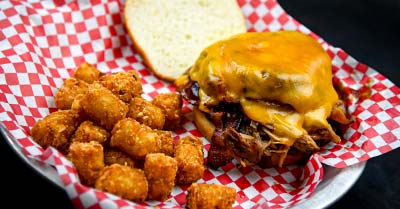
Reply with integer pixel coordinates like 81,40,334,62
180,81,349,168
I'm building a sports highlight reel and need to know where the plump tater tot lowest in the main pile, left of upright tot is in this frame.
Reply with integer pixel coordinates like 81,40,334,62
95,164,148,202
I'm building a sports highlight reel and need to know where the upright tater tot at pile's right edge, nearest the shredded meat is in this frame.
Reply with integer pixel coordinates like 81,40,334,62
175,136,204,184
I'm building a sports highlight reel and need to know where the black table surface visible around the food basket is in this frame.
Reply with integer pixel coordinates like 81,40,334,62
0,0,400,209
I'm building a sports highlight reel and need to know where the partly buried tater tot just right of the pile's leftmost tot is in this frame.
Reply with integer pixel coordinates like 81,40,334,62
72,120,110,146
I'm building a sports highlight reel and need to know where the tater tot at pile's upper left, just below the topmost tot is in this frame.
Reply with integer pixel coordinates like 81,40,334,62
54,77,89,110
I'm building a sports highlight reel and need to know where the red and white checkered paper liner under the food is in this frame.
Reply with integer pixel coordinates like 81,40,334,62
0,0,400,208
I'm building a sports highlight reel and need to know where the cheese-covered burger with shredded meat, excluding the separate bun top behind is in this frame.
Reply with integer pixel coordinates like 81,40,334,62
175,31,349,167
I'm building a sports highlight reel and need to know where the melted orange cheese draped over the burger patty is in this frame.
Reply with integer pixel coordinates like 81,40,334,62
189,31,338,146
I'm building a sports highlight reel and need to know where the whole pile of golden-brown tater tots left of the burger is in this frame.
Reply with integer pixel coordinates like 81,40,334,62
31,63,236,209
